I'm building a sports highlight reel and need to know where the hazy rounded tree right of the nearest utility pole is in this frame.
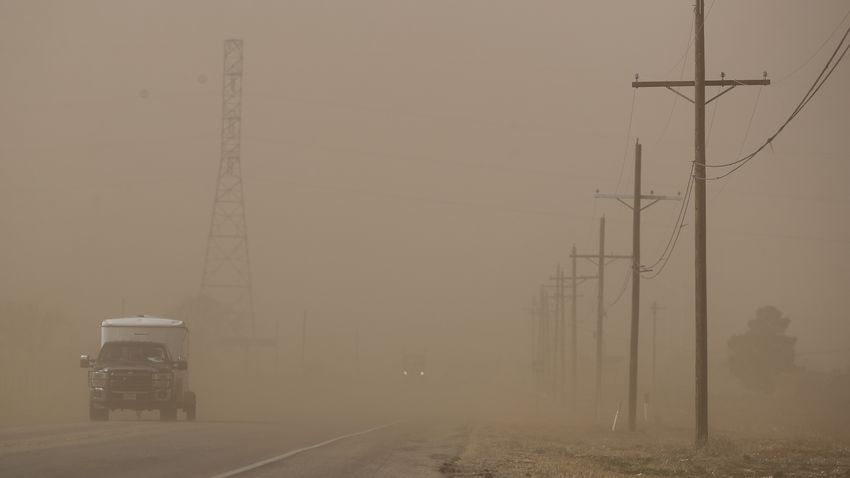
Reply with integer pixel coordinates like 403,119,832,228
729,305,797,393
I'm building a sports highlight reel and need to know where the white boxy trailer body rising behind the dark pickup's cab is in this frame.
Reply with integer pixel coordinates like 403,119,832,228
100,315,189,360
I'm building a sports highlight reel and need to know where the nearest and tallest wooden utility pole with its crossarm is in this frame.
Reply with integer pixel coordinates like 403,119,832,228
632,0,770,448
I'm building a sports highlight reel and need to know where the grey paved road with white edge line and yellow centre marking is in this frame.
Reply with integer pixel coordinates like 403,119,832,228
0,419,468,478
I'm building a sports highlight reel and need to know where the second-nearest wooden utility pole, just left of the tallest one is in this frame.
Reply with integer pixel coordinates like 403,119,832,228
596,141,681,431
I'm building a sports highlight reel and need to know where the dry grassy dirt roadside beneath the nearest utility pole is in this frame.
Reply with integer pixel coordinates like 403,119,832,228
441,423,850,478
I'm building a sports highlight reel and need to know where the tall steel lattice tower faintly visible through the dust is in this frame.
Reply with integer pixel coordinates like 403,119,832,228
201,40,254,335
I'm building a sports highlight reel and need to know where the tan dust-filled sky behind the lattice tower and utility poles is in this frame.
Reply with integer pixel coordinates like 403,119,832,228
0,0,850,374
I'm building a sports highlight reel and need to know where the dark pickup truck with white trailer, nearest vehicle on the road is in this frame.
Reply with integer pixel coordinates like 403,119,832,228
80,316,197,421
